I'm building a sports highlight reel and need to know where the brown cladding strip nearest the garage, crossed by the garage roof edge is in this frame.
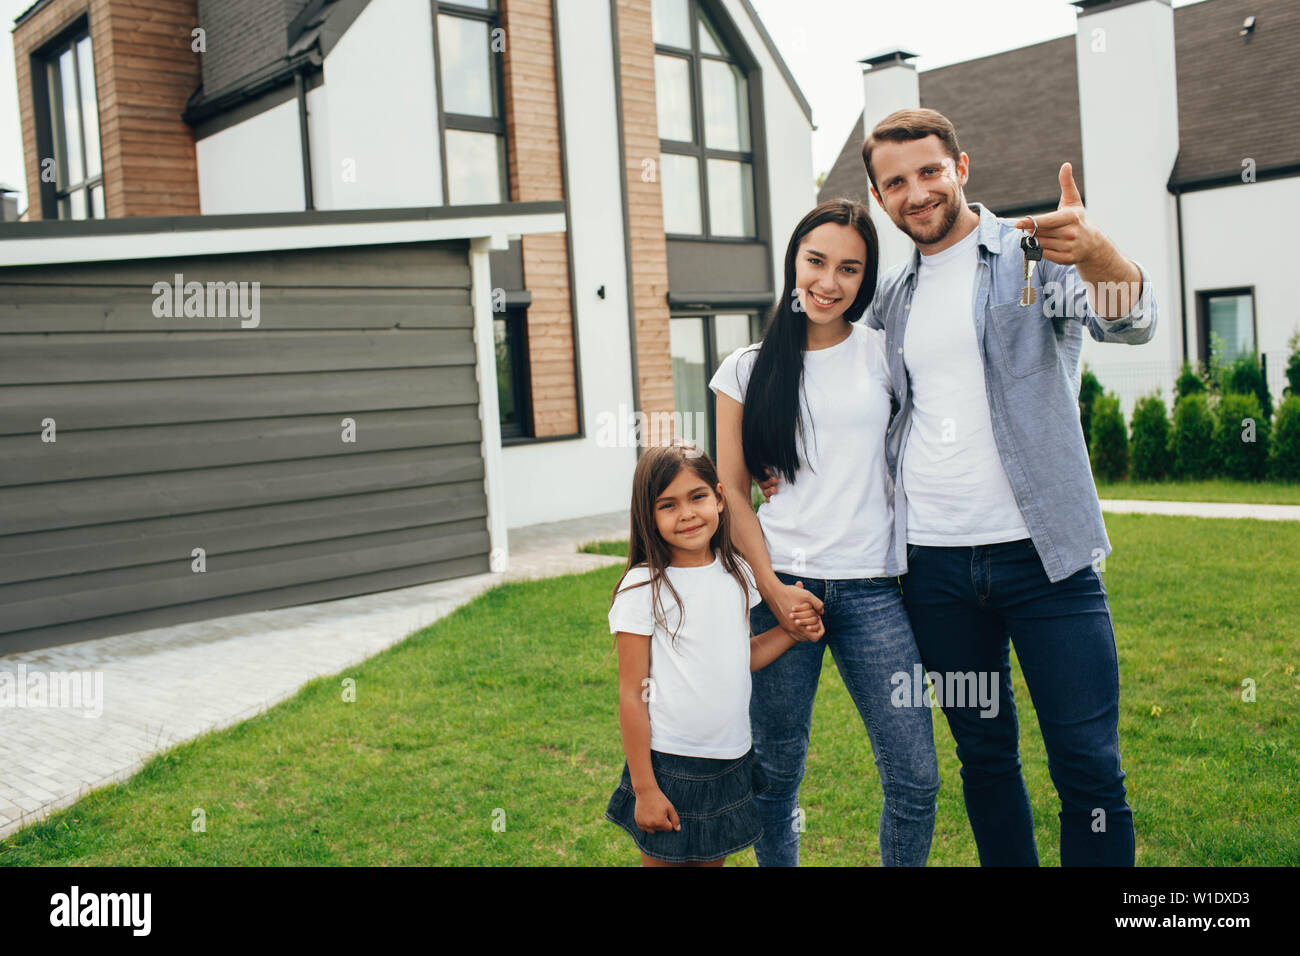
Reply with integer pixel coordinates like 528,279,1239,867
501,0,579,437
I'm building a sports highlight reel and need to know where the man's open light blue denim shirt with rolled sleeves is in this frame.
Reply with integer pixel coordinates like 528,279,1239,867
862,203,1156,581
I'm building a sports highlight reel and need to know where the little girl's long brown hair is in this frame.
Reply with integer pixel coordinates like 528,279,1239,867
610,438,750,641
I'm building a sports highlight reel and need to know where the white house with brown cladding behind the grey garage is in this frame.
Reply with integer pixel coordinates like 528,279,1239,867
14,0,815,527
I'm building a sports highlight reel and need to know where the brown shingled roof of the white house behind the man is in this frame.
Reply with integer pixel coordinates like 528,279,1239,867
818,0,1300,215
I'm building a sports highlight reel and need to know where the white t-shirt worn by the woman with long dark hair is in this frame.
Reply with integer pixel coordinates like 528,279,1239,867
709,324,893,579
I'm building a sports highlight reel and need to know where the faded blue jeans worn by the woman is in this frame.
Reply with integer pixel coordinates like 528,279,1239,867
749,571,939,866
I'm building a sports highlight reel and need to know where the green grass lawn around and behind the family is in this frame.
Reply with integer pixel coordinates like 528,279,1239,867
0,515,1300,866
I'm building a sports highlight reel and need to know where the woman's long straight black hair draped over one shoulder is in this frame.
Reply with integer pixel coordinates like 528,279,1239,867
741,199,880,481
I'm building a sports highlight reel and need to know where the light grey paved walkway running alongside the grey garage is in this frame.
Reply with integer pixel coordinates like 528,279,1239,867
0,511,628,836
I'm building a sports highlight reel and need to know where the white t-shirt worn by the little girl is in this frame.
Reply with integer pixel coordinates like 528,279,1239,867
610,551,762,760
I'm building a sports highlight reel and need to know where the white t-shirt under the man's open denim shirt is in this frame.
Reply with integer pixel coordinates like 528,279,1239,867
902,221,1030,548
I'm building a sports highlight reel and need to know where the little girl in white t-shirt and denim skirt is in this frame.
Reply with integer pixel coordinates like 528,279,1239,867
605,438,823,866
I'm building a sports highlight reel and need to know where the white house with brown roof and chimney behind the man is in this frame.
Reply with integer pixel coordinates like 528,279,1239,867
820,0,1300,408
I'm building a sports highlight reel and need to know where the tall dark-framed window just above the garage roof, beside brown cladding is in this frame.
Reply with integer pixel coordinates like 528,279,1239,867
434,0,510,206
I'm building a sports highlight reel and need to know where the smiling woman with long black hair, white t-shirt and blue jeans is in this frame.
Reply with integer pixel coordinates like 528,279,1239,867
709,199,939,866
